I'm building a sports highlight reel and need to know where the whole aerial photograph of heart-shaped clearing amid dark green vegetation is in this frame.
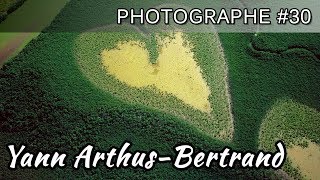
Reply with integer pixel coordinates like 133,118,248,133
0,0,320,180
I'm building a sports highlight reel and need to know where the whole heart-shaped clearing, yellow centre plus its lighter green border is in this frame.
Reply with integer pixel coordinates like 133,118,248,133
74,26,233,140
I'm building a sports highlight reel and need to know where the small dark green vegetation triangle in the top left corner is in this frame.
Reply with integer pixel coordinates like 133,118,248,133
0,0,26,23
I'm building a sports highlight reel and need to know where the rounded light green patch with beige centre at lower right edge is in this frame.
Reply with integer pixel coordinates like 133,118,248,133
260,99,320,179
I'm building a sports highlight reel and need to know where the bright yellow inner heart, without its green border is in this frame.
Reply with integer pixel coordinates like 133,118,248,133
101,33,210,113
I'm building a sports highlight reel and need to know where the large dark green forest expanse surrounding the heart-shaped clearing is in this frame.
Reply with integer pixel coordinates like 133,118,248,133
0,0,320,179
